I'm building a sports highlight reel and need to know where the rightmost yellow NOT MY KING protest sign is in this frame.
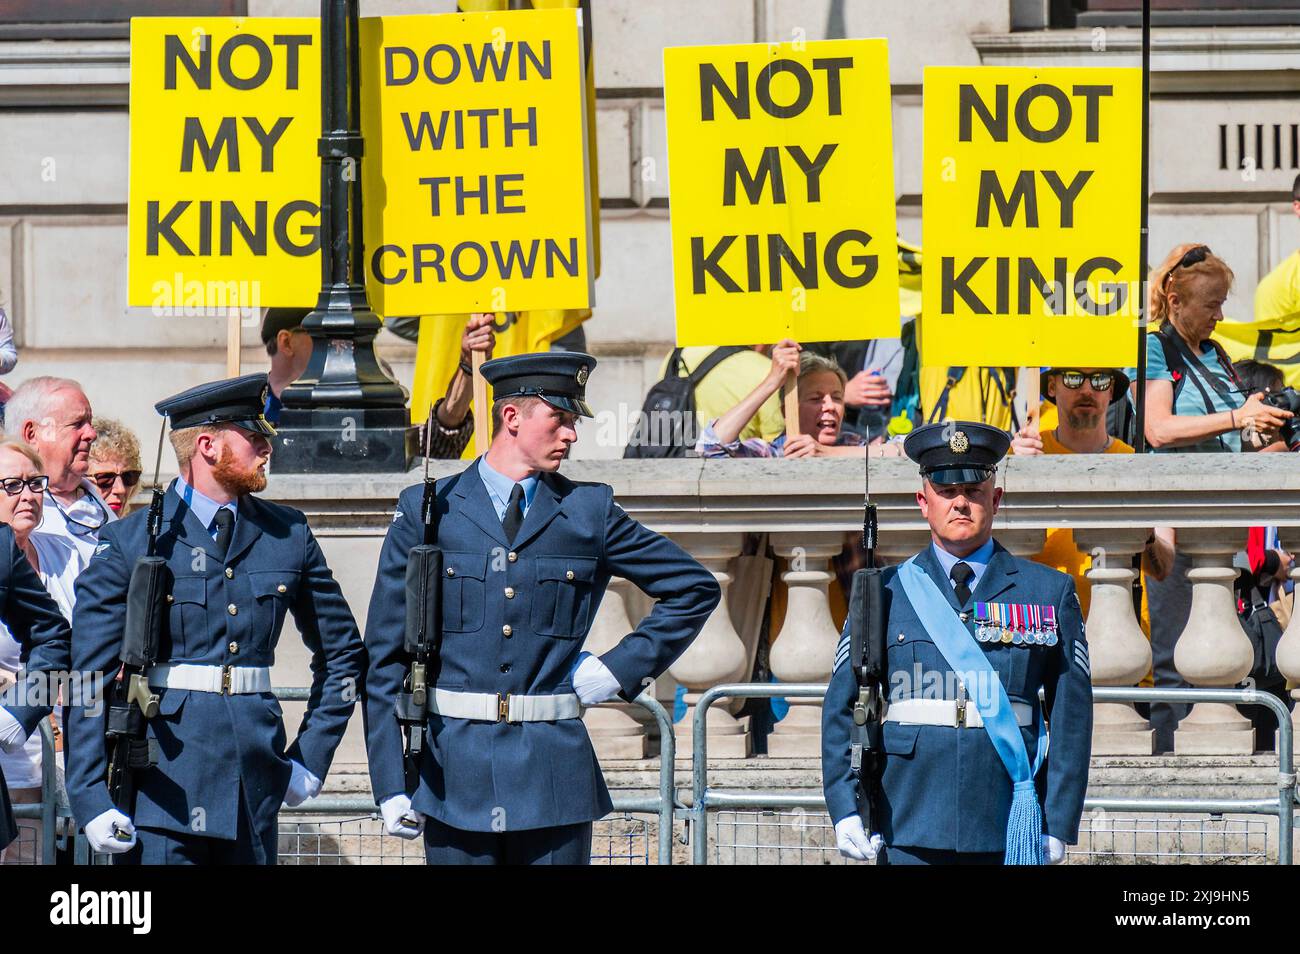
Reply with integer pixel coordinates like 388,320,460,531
920,66,1143,367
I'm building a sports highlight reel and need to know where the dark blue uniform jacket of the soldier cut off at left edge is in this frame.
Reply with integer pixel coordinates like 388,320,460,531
0,524,72,849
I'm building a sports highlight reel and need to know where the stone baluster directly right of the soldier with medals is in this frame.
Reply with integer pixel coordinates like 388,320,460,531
1074,528,1156,755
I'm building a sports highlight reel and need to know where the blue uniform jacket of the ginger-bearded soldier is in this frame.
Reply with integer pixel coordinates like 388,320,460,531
68,485,365,838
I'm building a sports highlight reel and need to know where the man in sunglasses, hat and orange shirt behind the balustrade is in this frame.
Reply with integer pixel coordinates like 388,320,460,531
1011,368,1174,633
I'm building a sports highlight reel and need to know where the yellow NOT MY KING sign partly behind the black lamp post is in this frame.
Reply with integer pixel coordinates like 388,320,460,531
127,17,321,313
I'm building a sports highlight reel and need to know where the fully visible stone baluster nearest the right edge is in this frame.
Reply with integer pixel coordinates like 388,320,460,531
1174,526,1255,755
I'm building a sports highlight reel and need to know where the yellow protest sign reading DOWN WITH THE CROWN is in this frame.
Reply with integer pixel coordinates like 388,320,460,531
361,9,594,315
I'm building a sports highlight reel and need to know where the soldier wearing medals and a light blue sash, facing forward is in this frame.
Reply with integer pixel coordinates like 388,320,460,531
822,421,1092,864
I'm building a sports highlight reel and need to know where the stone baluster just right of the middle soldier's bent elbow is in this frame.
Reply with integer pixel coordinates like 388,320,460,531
668,533,750,759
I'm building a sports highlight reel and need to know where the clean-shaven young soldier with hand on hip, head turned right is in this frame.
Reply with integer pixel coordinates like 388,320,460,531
365,352,720,864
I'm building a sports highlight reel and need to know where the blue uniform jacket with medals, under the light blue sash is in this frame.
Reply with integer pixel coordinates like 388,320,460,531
822,545,1092,851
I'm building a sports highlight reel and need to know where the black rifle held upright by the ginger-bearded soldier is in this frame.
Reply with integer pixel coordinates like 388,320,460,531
105,419,172,841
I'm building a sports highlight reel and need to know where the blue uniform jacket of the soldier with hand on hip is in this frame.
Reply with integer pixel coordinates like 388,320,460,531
365,463,720,832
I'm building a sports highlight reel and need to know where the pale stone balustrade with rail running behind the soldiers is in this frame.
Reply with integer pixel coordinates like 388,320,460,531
265,454,1300,762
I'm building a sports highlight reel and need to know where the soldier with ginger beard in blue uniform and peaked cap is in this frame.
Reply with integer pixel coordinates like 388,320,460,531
68,374,365,864
